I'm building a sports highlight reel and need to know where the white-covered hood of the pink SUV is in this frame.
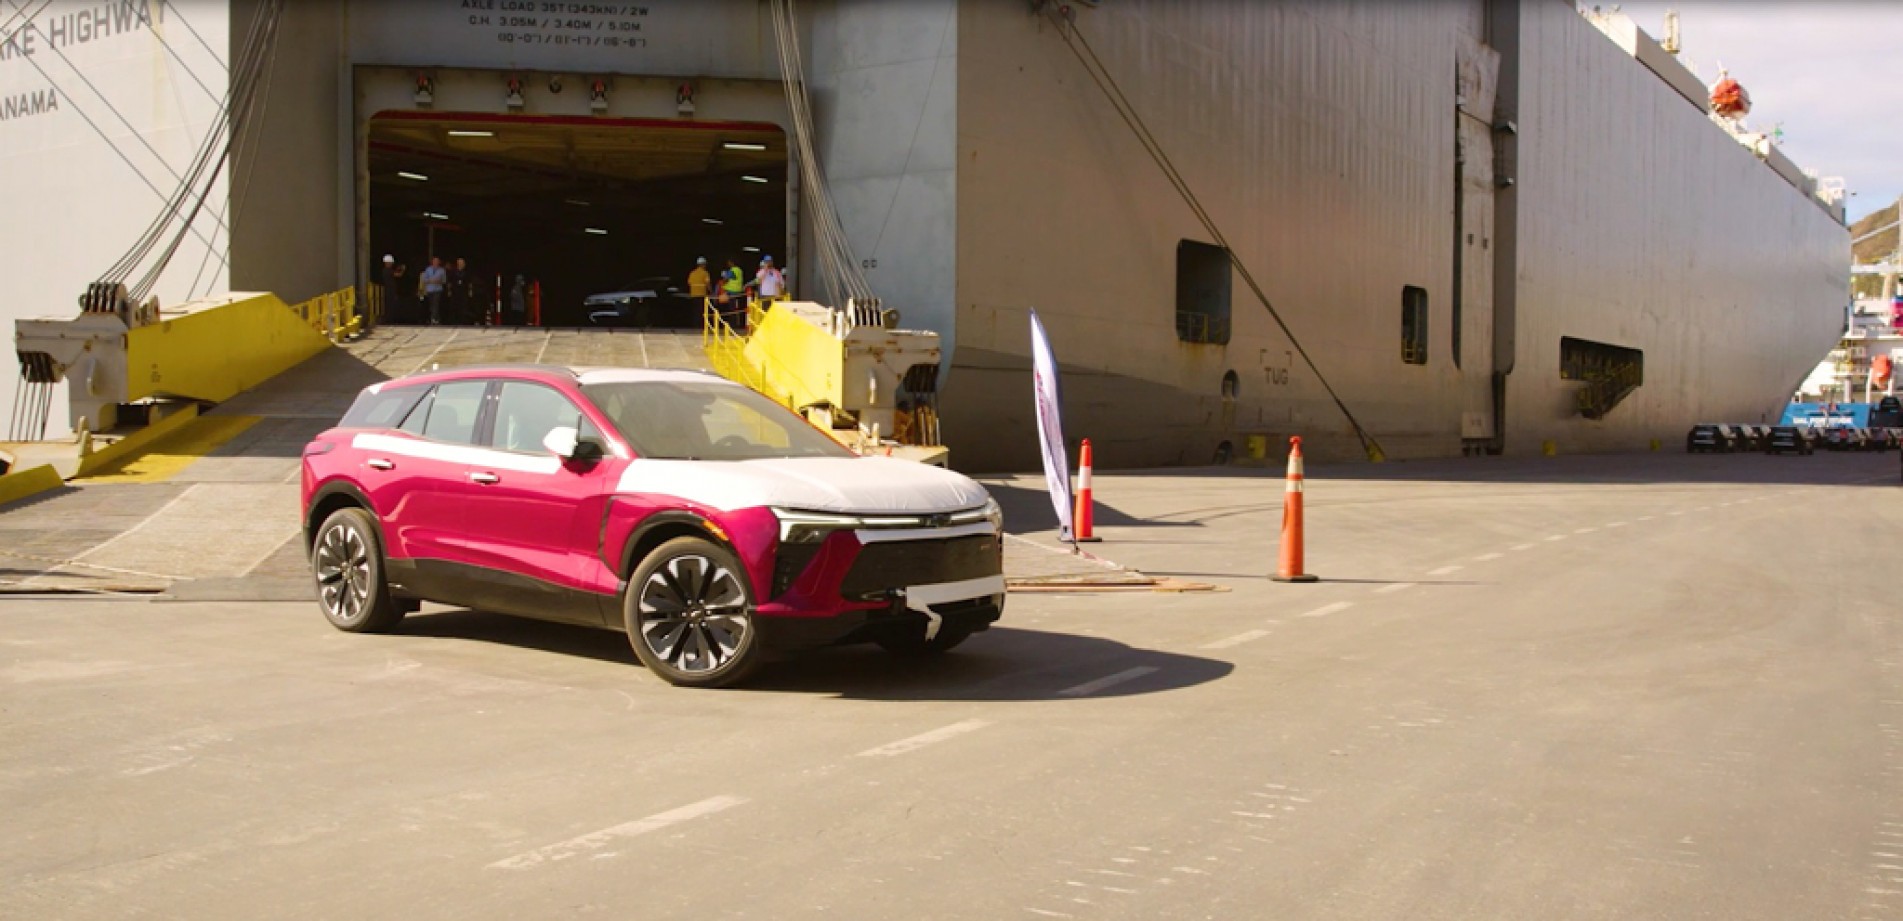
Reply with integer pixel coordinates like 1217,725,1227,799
617,457,990,514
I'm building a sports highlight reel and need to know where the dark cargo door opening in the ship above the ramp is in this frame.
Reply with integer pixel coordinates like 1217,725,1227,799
365,110,790,327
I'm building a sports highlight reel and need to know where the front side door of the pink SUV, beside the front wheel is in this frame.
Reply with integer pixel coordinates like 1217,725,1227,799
466,381,620,624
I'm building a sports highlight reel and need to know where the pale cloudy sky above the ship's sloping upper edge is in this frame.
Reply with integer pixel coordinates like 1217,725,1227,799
1600,0,1903,221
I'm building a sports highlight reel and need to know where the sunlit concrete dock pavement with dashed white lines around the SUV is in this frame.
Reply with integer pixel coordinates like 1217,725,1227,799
0,455,1903,919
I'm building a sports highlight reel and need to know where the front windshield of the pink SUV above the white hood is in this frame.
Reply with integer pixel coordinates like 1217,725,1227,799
582,381,853,461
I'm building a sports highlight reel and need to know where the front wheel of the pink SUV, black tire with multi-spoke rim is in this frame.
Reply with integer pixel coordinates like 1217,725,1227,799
622,537,761,687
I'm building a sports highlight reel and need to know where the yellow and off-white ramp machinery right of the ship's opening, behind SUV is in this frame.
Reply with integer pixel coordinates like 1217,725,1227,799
700,299,948,466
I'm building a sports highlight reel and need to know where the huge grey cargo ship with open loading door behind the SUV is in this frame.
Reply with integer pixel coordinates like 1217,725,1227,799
0,0,1850,470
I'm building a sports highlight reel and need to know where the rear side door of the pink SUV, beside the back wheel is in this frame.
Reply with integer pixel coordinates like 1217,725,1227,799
352,381,489,601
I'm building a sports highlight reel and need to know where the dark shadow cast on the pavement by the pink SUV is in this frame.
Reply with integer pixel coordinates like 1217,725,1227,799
398,611,1235,700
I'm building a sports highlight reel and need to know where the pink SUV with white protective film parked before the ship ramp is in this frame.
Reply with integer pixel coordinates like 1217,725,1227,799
303,365,1005,687
